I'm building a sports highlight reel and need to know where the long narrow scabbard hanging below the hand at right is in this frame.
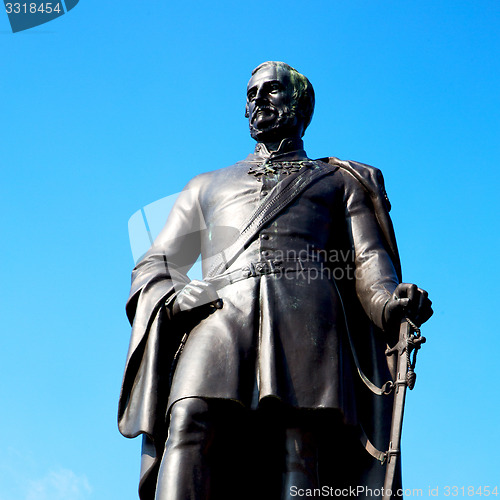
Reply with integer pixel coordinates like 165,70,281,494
383,318,411,500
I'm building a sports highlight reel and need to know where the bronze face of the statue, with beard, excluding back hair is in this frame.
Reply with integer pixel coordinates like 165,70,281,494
247,66,303,142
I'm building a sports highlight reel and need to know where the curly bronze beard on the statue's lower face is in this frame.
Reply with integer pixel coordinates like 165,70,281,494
249,105,297,141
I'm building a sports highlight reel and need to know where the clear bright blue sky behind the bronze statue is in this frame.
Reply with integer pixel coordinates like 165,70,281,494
0,0,500,500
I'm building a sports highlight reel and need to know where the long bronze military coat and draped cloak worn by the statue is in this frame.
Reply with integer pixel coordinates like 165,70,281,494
119,140,401,498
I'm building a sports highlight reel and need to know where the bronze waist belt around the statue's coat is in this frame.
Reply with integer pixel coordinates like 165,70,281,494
205,260,324,289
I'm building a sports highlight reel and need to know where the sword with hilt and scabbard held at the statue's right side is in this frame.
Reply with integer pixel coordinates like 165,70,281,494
383,318,426,500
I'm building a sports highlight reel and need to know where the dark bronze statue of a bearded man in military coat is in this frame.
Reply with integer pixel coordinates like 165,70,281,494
119,62,432,500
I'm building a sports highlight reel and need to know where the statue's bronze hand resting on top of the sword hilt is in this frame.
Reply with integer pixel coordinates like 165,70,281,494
384,283,434,331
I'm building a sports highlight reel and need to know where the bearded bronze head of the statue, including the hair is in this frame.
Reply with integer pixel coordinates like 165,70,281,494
245,61,314,142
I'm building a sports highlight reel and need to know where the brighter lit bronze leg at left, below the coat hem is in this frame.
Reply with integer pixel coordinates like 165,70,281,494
155,398,214,500
